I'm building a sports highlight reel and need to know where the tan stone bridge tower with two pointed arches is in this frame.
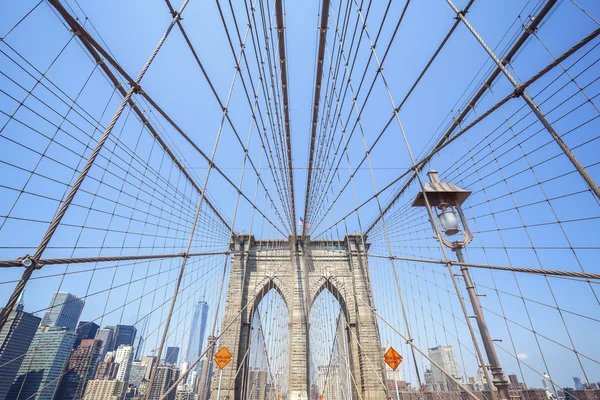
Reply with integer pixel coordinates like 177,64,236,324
210,234,387,400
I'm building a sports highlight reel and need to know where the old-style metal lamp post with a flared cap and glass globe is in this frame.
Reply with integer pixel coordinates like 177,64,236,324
413,170,510,400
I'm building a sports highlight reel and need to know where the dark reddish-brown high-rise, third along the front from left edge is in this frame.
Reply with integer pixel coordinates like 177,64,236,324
55,339,102,400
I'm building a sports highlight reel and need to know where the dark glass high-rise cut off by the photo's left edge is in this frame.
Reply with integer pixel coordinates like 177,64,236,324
0,297,42,399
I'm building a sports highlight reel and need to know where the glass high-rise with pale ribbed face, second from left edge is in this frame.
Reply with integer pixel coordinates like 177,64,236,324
7,325,77,400
